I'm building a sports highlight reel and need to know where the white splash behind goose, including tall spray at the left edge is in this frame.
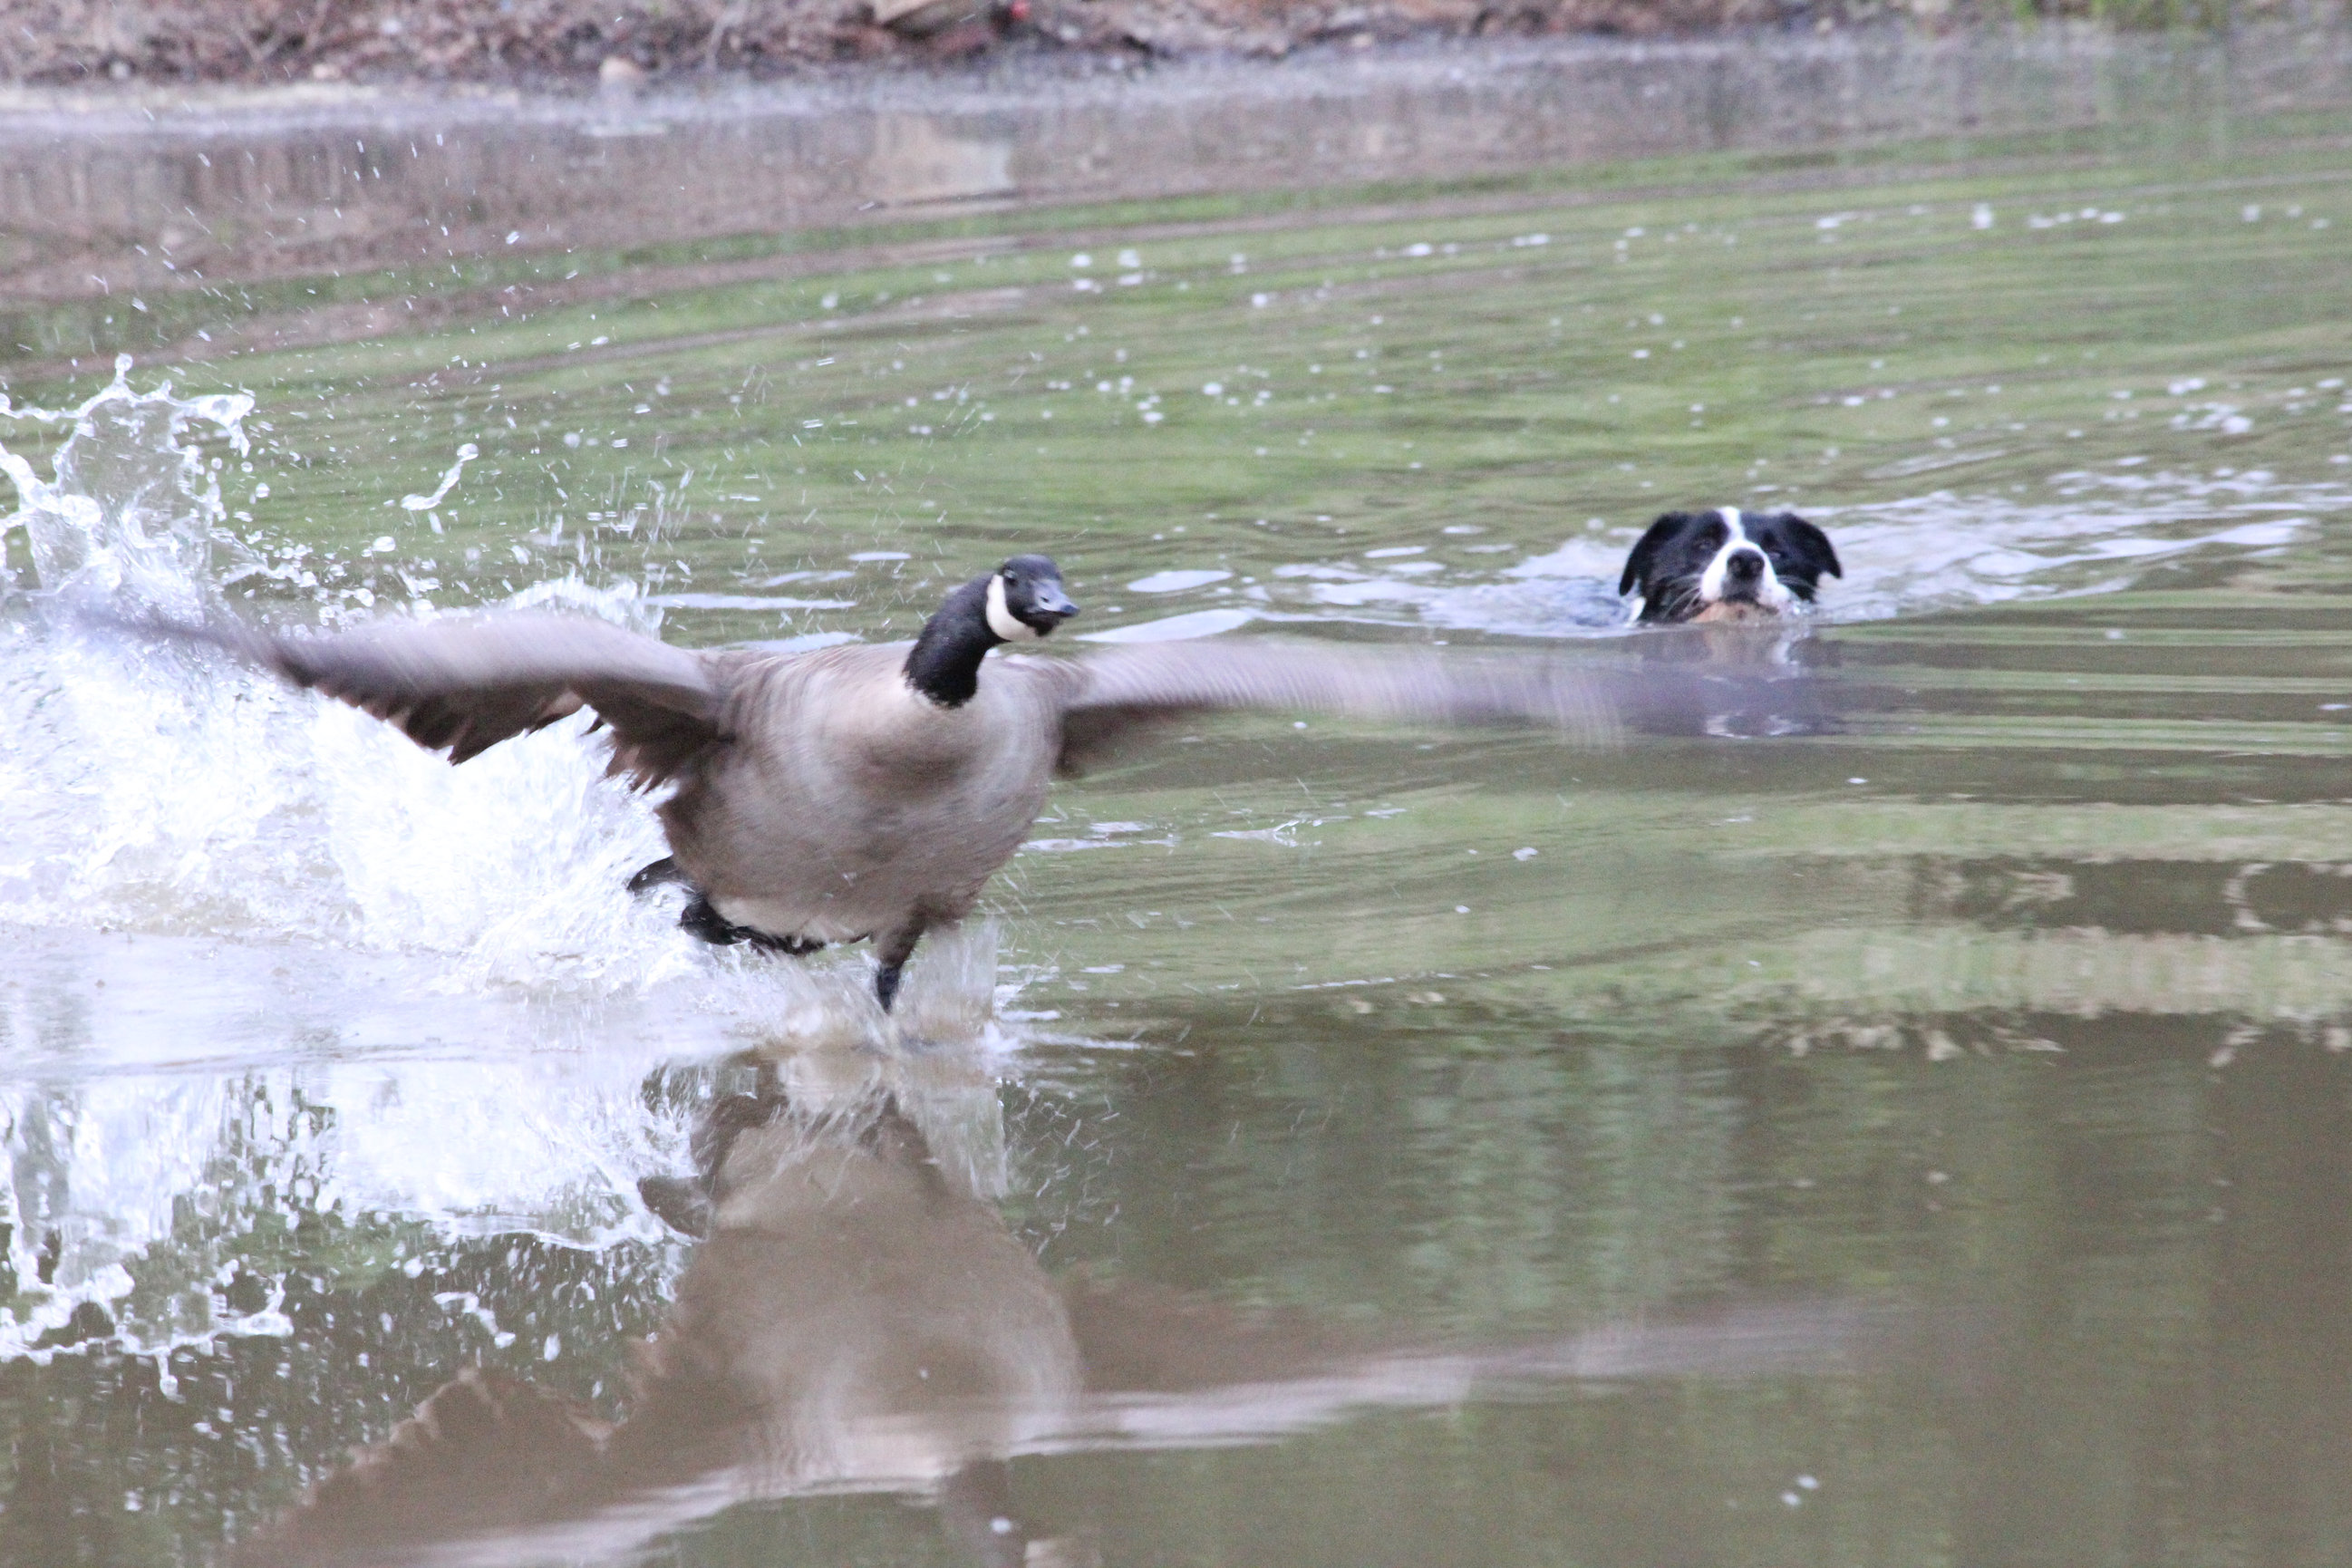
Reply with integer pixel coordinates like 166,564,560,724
0,369,684,981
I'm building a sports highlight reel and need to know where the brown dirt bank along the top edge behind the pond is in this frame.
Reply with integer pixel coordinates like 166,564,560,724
0,0,2312,87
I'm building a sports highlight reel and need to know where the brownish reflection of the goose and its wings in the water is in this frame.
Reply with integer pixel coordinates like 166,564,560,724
237,1065,1896,1568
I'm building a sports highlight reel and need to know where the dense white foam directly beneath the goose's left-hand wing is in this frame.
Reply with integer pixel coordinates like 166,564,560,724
0,576,692,987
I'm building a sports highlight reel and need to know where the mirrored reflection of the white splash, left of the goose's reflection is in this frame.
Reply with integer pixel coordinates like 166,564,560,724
0,1024,684,1357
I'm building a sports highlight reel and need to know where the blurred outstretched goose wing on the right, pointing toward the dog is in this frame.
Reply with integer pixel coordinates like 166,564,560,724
1060,637,1689,769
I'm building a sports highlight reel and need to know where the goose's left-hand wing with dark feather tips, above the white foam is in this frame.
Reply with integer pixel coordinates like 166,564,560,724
139,614,724,788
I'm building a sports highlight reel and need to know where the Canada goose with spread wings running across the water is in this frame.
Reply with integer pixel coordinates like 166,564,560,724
146,555,1740,1009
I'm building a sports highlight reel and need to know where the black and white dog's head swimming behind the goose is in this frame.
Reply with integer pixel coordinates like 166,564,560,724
1618,506,1844,625
